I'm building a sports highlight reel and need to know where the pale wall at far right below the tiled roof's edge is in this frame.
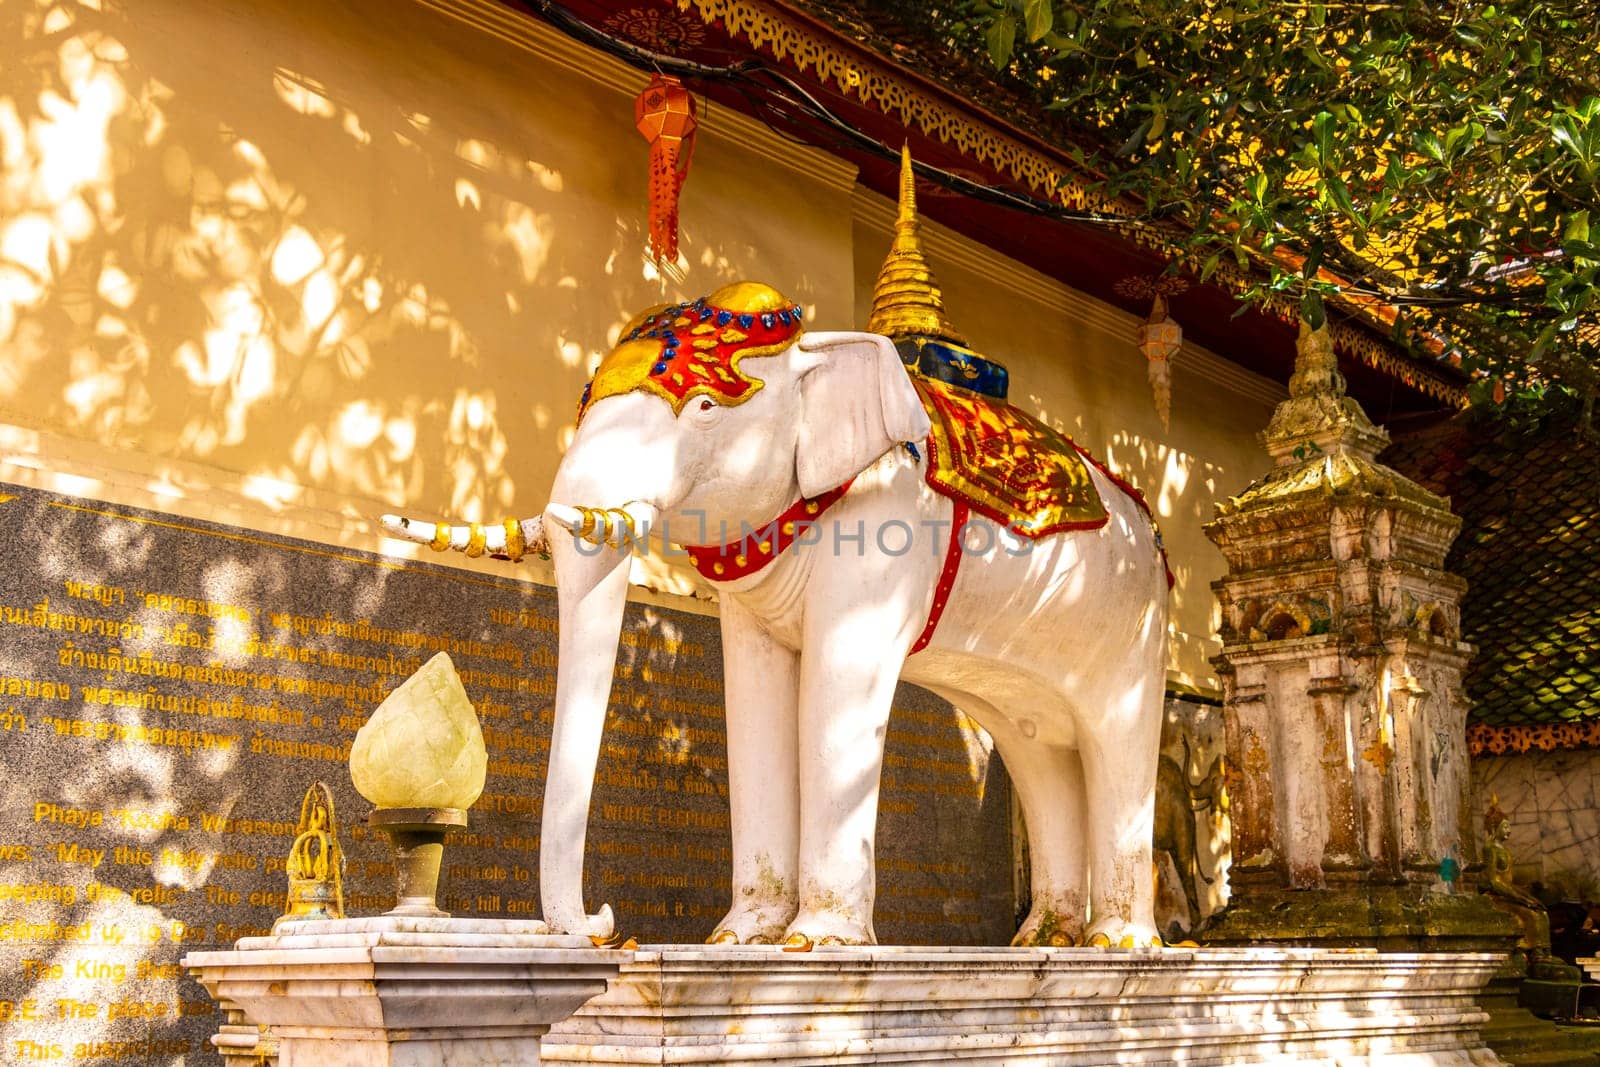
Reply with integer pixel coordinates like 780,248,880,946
1472,749,1600,901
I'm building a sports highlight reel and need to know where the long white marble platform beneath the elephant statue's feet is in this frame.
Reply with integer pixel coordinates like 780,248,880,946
542,945,1501,1067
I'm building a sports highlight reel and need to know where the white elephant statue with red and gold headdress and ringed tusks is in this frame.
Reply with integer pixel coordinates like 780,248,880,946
386,283,1168,947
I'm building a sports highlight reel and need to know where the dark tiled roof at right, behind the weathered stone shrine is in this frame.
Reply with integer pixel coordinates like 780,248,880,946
1384,414,1600,752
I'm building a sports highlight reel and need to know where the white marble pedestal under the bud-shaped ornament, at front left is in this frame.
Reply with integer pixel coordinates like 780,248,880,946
184,915,632,1067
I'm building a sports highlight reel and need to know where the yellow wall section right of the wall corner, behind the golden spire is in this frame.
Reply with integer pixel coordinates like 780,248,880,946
854,189,1285,689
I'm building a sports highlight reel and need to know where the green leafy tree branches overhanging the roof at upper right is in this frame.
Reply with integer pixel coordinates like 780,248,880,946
934,0,1600,415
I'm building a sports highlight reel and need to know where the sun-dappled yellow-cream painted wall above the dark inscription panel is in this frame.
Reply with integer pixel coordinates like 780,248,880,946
0,0,1274,686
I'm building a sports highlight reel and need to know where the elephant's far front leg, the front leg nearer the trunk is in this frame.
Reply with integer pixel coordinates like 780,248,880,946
709,597,800,945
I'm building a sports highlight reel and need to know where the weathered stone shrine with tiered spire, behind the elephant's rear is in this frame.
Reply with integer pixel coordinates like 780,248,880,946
1202,330,1515,950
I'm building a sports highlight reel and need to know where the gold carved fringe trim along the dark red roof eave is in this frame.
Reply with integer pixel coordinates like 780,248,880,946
677,0,1467,406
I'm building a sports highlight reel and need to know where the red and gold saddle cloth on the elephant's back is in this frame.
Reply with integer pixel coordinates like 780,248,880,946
912,374,1106,539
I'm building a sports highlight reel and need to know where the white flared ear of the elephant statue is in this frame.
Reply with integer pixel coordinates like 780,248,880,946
795,333,928,498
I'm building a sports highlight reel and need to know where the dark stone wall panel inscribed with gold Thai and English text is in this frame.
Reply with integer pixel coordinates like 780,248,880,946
0,485,1014,1064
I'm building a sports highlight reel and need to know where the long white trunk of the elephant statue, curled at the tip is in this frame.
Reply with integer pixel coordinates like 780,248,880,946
539,502,654,937
